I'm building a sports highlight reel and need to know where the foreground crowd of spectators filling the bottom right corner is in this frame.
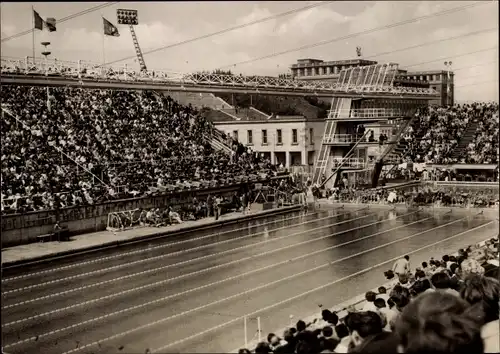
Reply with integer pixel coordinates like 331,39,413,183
239,238,500,354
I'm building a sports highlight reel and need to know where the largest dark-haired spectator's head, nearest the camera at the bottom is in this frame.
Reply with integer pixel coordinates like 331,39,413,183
395,292,484,354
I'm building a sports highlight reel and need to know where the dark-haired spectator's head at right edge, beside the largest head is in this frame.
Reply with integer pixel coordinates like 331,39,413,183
460,274,500,323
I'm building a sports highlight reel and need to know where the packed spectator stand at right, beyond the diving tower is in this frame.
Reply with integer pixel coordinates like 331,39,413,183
403,103,499,164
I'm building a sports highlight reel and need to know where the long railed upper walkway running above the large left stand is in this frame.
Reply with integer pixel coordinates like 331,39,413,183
1,57,437,97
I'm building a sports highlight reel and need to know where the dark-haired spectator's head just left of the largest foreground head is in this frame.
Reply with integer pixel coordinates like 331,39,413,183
345,311,383,346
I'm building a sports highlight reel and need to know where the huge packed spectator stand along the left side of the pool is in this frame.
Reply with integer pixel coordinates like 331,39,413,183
1,85,275,213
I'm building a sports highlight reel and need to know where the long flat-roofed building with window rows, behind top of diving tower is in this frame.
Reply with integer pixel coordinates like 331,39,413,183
290,59,454,106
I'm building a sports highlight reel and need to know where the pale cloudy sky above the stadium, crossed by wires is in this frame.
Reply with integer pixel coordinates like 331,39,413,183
1,1,498,101
